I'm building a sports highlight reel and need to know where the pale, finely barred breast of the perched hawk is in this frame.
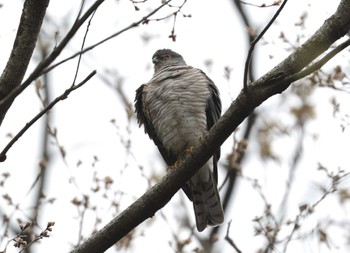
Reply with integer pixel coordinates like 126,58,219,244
145,67,210,154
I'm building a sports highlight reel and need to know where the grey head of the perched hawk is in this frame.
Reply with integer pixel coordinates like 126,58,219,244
152,49,186,72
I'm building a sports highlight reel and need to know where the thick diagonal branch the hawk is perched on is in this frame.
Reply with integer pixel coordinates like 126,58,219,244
72,0,350,253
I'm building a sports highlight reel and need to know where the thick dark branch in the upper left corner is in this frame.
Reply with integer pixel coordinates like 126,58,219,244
0,0,49,124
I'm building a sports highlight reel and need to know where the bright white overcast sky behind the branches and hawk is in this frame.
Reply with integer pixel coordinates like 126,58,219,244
0,0,350,253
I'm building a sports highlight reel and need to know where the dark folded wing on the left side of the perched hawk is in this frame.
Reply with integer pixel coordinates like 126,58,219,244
135,84,177,166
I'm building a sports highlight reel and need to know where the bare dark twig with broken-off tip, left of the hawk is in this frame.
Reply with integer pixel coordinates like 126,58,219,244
0,70,96,162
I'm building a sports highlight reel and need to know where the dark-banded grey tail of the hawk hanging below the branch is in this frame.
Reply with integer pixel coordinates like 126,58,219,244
190,162,224,231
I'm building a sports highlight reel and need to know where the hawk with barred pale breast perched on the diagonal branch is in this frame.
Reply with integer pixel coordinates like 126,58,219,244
134,49,224,232
